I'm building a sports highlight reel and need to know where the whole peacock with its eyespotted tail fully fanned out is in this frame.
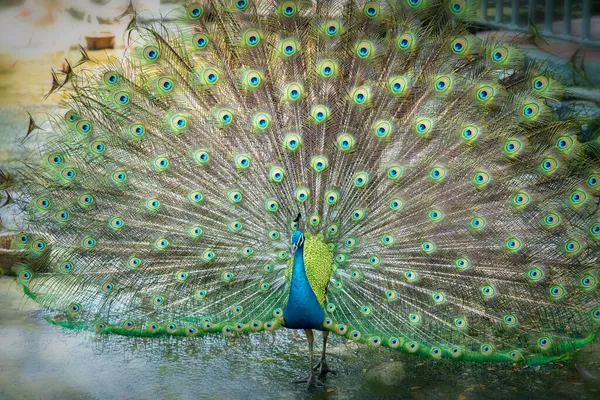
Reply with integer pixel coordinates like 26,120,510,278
4,0,600,386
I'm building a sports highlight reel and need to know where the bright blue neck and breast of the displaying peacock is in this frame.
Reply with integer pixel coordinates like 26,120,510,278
283,245,325,330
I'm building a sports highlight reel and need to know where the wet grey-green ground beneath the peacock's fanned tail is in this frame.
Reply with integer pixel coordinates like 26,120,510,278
0,277,600,400
